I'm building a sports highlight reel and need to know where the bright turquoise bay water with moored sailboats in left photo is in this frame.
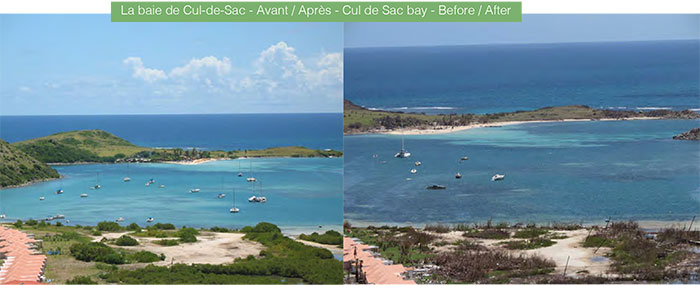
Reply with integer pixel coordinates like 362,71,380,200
0,158,343,231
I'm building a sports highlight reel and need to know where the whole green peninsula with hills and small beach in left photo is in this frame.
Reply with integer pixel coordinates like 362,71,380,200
0,130,343,187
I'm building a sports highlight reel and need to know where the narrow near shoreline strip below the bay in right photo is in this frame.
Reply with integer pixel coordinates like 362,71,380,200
345,216,700,231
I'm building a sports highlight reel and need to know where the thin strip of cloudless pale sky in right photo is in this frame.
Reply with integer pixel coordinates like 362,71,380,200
345,15,700,48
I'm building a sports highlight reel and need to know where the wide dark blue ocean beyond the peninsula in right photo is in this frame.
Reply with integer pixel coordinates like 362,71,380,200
344,40,700,113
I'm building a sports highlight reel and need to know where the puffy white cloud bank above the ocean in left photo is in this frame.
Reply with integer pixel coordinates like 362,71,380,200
124,41,343,111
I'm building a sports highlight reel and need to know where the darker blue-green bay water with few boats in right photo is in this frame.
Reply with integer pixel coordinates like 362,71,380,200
344,120,700,224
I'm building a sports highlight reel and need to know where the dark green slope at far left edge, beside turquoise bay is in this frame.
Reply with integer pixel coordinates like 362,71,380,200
0,139,59,187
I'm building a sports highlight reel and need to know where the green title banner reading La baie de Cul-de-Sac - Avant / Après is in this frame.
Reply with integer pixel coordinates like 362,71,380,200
112,2,522,22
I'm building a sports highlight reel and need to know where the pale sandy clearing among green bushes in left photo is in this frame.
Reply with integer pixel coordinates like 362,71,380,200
94,233,265,265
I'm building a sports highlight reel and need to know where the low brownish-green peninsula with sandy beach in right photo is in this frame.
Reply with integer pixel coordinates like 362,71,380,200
343,100,700,133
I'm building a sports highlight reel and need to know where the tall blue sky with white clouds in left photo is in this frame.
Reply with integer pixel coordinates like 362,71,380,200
0,15,343,115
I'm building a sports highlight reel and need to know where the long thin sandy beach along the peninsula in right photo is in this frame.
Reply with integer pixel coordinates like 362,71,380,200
375,117,661,135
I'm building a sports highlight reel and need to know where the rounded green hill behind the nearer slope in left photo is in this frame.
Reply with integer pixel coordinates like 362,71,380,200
13,130,149,163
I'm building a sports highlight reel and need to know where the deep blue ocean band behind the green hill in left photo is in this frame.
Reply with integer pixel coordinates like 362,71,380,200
0,113,343,150
